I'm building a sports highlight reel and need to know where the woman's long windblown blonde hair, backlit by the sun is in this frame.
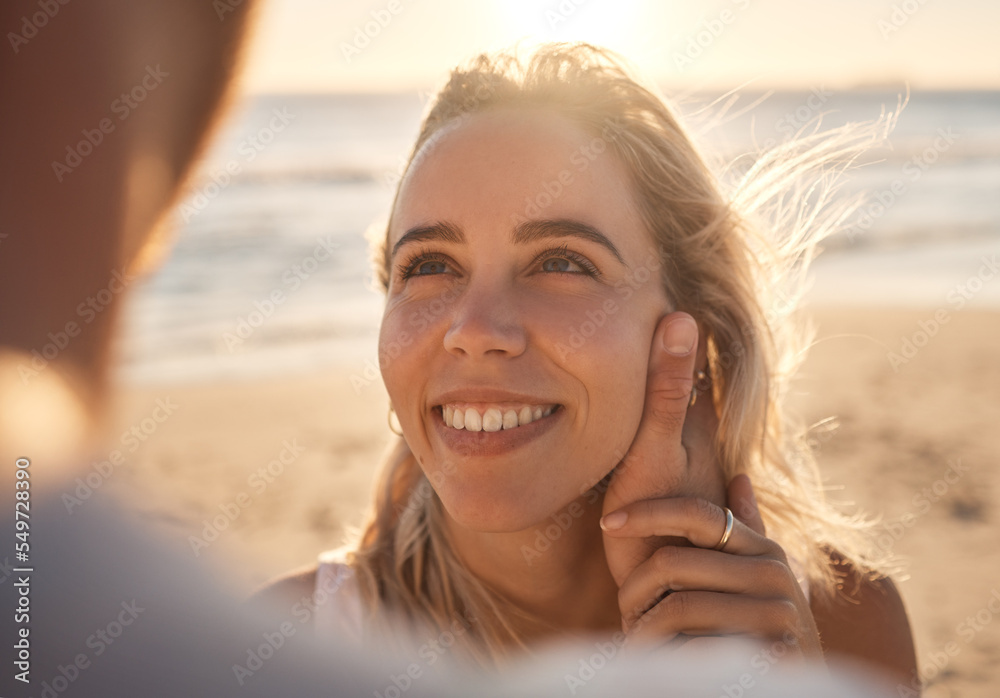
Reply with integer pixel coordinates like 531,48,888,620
348,44,892,665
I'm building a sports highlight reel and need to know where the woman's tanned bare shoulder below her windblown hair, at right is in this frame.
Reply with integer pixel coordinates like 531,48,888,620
810,553,917,681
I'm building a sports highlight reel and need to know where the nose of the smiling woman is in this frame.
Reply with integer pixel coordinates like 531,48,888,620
444,283,527,358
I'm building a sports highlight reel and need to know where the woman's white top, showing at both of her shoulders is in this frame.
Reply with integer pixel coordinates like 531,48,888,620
313,548,809,644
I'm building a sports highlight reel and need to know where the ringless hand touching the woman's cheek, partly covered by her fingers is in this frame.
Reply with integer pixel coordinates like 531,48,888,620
602,312,725,587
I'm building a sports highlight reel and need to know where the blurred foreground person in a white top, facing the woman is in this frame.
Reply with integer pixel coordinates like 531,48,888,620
0,0,908,697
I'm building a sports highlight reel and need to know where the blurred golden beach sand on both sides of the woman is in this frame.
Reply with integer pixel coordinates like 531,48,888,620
104,308,1000,697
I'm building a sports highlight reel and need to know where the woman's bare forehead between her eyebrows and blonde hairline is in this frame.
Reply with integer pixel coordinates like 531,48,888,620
389,109,651,259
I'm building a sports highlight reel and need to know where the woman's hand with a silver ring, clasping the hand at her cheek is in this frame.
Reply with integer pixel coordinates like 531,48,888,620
602,475,823,659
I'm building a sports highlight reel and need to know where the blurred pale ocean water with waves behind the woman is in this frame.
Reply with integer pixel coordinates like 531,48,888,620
119,88,1000,382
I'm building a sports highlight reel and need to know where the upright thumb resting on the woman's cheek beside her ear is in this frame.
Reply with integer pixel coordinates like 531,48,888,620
642,312,698,438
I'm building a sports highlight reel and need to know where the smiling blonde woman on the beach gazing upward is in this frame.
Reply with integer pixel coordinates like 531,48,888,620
269,45,915,680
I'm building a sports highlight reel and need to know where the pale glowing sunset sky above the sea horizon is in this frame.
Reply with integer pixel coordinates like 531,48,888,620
243,0,1000,93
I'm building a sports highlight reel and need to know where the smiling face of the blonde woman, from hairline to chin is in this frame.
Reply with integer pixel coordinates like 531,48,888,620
379,109,670,532
